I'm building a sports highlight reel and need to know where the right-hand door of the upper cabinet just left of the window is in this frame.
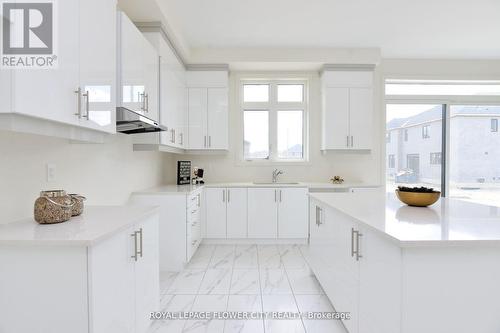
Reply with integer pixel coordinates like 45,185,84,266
207,88,228,149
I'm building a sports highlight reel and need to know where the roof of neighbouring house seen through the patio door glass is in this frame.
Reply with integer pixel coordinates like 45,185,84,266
386,105,500,130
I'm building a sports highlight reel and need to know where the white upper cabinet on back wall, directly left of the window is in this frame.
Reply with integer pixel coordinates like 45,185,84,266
186,71,229,150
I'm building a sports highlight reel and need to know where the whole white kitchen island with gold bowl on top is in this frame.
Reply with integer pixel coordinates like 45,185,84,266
303,191,500,333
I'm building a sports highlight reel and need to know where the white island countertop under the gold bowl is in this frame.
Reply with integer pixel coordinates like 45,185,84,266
309,191,500,246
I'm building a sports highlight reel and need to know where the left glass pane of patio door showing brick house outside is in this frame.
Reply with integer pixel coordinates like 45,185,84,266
386,104,443,192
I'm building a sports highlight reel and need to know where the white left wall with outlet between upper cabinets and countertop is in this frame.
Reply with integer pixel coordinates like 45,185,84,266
0,131,175,223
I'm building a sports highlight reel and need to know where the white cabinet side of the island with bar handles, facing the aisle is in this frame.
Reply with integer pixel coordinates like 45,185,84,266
303,199,401,333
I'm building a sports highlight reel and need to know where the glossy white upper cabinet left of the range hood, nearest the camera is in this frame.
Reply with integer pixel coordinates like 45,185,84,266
0,0,116,139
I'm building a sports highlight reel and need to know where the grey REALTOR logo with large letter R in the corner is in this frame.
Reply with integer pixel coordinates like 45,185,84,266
1,0,57,68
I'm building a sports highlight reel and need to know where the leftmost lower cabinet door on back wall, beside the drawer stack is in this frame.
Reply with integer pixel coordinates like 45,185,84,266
205,188,227,238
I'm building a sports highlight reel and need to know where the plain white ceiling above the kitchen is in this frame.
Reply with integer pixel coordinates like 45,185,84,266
157,0,500,58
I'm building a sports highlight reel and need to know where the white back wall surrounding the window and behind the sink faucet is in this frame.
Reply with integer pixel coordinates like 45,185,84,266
176,72,383,184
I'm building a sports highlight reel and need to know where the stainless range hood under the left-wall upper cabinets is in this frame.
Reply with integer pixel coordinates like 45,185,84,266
116,107,167,134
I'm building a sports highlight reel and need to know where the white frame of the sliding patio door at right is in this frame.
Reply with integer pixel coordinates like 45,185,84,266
382,75,500,197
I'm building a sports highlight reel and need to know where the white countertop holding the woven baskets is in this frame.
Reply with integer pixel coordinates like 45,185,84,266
0,206,158,246
